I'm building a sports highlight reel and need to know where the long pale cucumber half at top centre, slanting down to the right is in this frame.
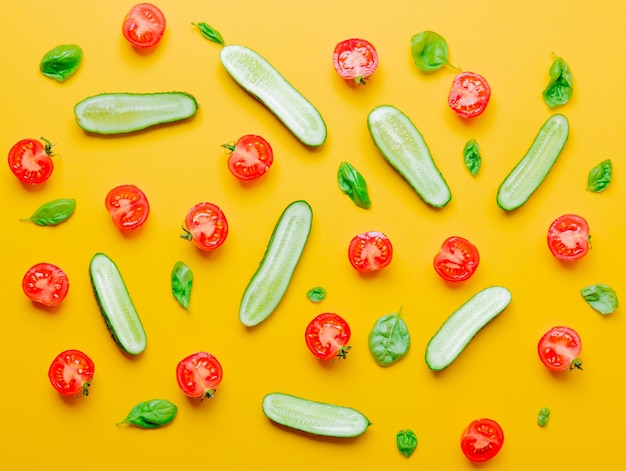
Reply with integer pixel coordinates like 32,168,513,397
220,45,326,147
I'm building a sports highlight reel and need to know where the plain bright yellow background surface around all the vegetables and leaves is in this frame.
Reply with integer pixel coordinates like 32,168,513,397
0,0,626,470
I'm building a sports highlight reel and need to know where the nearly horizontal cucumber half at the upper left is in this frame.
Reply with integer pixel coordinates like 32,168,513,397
74,92,198,134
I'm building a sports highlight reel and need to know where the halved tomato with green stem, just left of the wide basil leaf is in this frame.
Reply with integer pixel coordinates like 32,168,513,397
304,312,350,360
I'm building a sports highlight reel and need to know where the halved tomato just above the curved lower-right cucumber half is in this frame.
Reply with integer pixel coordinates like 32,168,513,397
433,236,480,281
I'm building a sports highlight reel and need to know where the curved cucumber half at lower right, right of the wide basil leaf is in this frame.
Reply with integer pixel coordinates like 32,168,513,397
426,286,511,371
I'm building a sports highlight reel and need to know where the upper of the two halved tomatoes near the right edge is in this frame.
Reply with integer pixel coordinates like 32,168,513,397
548,214,591,261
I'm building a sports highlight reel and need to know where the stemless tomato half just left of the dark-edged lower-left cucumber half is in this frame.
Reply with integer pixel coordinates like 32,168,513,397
22,263,70,306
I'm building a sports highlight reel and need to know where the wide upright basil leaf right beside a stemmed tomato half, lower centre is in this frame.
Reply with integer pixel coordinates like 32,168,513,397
368,311,411,366
